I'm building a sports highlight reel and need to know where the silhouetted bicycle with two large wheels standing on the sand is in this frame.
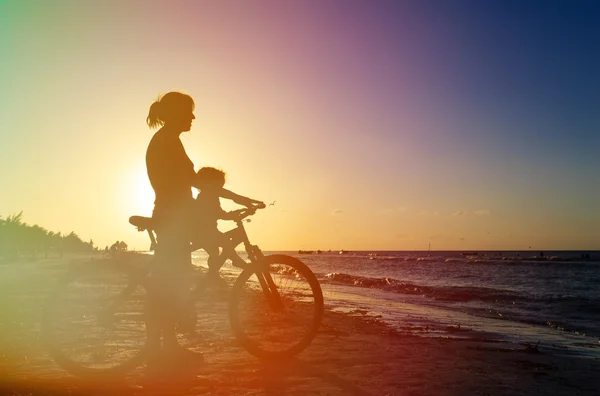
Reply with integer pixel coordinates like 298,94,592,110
42,207,324,377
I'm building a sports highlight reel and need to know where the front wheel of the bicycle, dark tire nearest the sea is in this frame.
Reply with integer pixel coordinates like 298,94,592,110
229,255,323,359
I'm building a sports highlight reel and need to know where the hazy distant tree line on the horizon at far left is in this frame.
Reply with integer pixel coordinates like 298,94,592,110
0,212,97,258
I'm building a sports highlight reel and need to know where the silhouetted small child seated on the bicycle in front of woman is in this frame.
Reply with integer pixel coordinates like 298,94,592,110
192,167,264,284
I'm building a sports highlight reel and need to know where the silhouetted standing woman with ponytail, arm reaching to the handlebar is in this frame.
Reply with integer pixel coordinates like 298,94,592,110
146,92,252,365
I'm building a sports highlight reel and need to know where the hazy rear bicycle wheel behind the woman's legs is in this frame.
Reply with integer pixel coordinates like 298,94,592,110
42,262,147,377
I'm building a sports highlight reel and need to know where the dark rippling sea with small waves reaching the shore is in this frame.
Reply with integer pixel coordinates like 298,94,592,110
194,251,600,357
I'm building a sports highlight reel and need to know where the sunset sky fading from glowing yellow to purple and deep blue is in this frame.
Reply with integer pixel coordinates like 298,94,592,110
0,0,600,250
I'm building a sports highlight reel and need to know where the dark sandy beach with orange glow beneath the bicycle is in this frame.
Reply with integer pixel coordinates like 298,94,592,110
0,255,600,395
